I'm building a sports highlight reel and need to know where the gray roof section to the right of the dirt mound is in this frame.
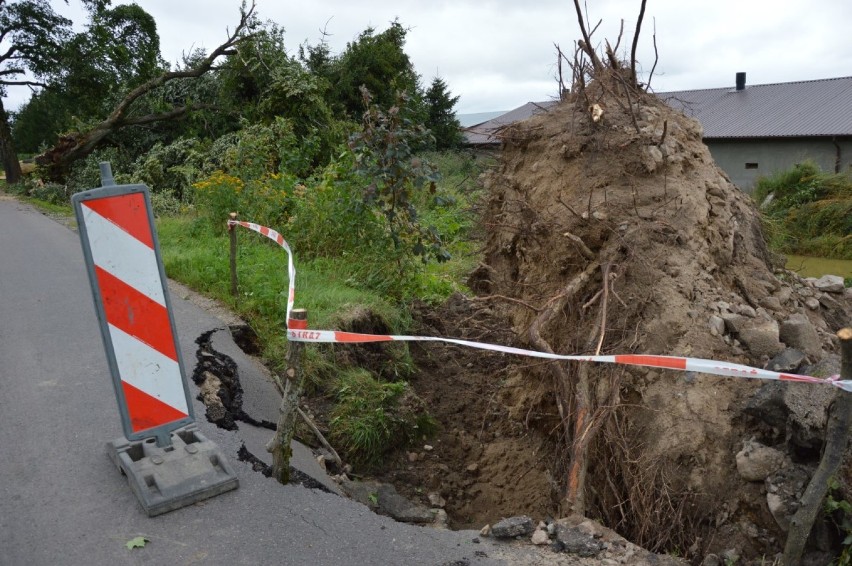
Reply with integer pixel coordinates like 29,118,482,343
657,77,852,139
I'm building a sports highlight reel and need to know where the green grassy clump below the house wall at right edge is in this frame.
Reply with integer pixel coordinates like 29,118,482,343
754,161,852,259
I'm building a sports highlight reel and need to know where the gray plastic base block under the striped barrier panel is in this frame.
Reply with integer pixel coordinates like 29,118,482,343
107,425,239,517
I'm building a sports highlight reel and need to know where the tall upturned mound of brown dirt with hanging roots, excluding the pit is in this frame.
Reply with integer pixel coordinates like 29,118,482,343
460,76,848,556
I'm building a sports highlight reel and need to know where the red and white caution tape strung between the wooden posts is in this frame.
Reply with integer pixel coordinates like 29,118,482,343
228,221,852,392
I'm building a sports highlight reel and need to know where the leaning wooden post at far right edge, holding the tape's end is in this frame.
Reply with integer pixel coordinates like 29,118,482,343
784,328,852,566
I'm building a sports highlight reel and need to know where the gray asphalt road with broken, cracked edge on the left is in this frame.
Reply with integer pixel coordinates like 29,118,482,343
0,193,520,566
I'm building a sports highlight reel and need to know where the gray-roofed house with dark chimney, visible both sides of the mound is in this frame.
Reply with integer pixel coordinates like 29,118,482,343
464,73,852,192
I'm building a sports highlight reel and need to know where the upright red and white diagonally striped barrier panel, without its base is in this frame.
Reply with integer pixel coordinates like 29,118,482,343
75,191,191,436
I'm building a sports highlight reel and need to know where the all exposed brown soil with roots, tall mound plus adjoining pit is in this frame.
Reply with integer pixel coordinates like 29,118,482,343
370,80,850,563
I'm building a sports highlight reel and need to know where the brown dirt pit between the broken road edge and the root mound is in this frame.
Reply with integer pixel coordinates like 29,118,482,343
378,295,559,529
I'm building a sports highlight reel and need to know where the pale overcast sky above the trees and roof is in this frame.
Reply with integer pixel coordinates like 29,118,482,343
8,0,852,114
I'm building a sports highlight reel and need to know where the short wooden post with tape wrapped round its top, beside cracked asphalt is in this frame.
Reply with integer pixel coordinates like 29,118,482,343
266,309,308,484
